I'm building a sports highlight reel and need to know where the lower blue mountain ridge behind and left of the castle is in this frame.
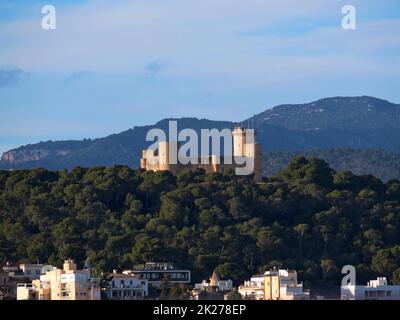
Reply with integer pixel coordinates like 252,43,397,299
0,118,234,169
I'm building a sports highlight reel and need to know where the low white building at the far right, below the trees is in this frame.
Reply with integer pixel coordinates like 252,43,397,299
340,277,400,300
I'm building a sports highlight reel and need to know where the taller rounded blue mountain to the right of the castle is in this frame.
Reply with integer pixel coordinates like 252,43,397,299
245,96,400,152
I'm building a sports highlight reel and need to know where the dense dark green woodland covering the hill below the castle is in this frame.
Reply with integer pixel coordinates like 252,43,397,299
0,157,400,287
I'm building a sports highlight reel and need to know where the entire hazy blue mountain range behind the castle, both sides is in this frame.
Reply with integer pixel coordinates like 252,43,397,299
0,96,400,173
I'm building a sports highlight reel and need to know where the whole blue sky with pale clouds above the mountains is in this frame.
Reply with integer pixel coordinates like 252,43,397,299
0,0,400,153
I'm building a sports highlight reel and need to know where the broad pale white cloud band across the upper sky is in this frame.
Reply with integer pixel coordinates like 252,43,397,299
0,0,400,86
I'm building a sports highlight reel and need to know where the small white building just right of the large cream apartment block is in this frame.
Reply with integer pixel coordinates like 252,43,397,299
105,272,149,300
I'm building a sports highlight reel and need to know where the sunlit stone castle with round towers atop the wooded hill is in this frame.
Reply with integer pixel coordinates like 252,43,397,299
140,127,262,182
